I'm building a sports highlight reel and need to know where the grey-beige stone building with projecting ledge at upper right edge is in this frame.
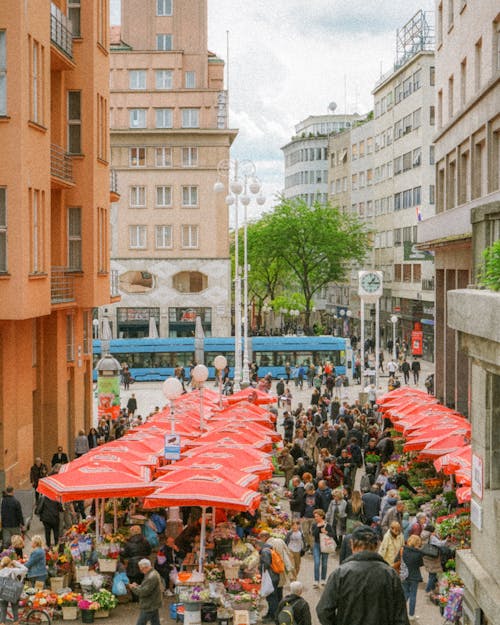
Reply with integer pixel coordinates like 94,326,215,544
418,0,500,414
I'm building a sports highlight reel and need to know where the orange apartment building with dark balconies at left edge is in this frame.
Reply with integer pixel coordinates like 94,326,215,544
0,0,118,488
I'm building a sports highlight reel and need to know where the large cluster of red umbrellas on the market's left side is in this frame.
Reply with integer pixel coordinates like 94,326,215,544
38,389,280,510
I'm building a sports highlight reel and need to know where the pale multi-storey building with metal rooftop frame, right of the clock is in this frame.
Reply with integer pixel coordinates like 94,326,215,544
373,39,435,360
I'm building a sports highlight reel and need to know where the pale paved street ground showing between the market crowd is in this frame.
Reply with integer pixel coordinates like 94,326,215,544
86,354,441,625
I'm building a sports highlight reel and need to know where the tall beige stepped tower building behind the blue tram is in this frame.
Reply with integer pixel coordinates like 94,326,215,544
107,0,236,338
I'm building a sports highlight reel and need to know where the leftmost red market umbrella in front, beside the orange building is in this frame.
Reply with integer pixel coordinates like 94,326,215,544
37,463,154,501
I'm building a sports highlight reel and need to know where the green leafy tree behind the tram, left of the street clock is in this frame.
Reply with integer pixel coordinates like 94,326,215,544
256,199,370,326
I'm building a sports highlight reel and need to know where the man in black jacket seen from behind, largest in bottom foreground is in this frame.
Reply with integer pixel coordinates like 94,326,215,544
316,525,409,625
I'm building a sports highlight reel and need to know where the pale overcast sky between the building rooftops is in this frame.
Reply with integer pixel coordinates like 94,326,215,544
111,0,434,212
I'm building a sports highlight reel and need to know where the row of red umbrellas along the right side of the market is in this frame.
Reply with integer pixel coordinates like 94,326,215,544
377,387,472,503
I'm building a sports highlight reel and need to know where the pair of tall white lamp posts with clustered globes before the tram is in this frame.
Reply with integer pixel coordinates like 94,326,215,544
214,160,266,391
